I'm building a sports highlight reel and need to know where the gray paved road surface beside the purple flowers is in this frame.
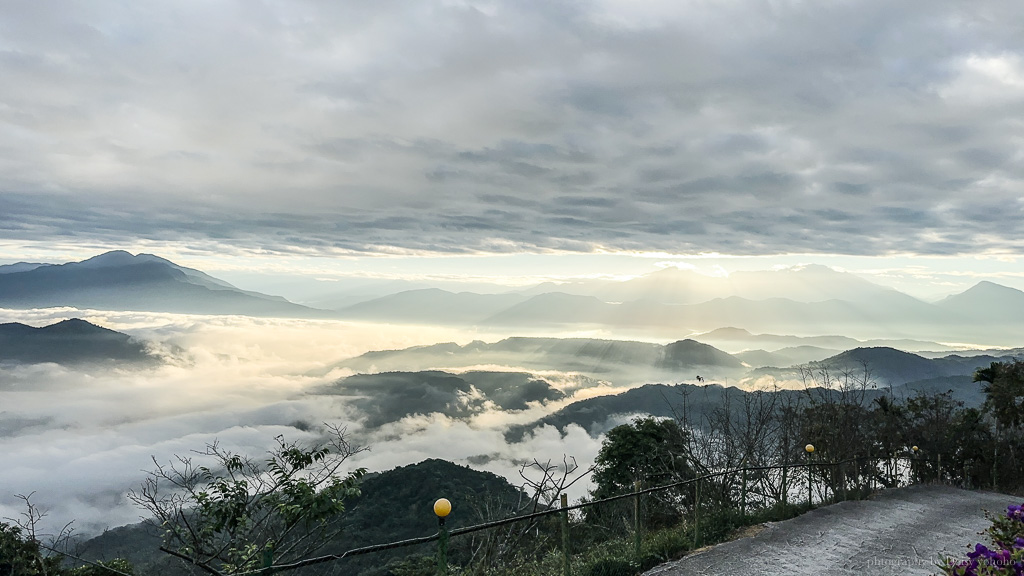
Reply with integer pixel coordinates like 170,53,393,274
644,486,1024,576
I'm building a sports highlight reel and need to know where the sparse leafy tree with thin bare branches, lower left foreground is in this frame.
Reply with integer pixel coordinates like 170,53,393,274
128,425,366,574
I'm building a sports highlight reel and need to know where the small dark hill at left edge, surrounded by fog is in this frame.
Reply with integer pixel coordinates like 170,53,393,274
0,318,157,364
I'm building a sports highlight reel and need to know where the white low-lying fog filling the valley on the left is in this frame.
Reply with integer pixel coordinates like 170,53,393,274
0,308,638,534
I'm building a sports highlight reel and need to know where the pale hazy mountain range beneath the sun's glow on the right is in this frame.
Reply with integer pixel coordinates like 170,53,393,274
325,266,1024,344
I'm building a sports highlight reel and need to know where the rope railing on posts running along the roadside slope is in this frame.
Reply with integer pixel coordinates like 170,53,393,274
230,455,918,576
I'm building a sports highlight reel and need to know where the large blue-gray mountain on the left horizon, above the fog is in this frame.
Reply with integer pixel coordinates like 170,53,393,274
0,250,329,318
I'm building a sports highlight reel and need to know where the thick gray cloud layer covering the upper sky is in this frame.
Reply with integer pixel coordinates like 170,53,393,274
0,0,1024,254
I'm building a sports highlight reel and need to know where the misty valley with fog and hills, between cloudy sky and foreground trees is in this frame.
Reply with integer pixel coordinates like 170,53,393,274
0,252,1021,573
